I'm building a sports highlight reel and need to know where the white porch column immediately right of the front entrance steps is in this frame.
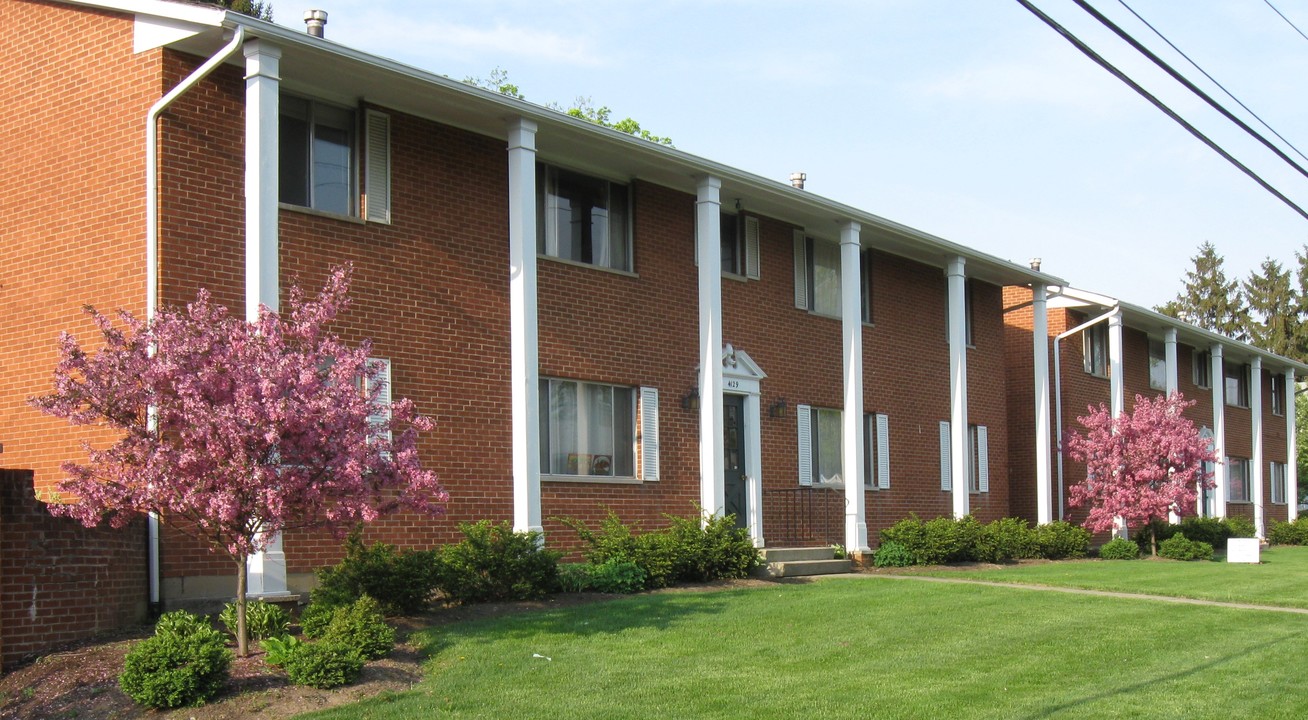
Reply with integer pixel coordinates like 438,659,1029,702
840,221,871,552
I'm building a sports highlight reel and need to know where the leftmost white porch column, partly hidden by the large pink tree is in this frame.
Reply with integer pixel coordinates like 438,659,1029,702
242,41,286,596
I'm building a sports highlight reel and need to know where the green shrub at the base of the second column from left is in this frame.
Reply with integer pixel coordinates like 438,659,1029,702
437,520,560,602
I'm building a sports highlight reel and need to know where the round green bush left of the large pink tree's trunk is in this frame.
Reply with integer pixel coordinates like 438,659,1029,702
118,610,232,708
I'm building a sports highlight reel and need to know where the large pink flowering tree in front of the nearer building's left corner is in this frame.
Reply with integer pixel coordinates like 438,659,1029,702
31,267,449,656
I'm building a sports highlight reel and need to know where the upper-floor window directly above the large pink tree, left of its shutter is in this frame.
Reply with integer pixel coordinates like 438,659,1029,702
277,96,357,215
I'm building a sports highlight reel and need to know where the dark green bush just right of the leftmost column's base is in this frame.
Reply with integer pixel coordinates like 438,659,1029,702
309,533,437,615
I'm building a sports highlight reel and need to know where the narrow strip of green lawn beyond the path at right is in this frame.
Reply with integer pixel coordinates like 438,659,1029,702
915,547,1308,607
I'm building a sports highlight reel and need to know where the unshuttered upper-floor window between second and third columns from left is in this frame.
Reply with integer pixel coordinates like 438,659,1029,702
536,165,632,271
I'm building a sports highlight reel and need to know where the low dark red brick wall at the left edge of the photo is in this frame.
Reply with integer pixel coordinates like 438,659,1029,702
0,470,146,669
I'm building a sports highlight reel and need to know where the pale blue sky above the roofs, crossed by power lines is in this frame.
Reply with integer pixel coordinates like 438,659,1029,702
275,0,1308,305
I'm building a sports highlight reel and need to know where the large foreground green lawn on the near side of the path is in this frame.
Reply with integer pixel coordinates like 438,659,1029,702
300,576,1308,720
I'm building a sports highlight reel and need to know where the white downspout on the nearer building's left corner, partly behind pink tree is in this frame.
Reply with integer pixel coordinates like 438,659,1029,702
145,26,245,614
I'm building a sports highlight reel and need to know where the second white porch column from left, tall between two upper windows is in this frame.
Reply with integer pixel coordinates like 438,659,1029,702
509,118,543,531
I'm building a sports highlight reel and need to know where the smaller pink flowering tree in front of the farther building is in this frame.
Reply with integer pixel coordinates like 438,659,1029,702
1065,393,1216,555
